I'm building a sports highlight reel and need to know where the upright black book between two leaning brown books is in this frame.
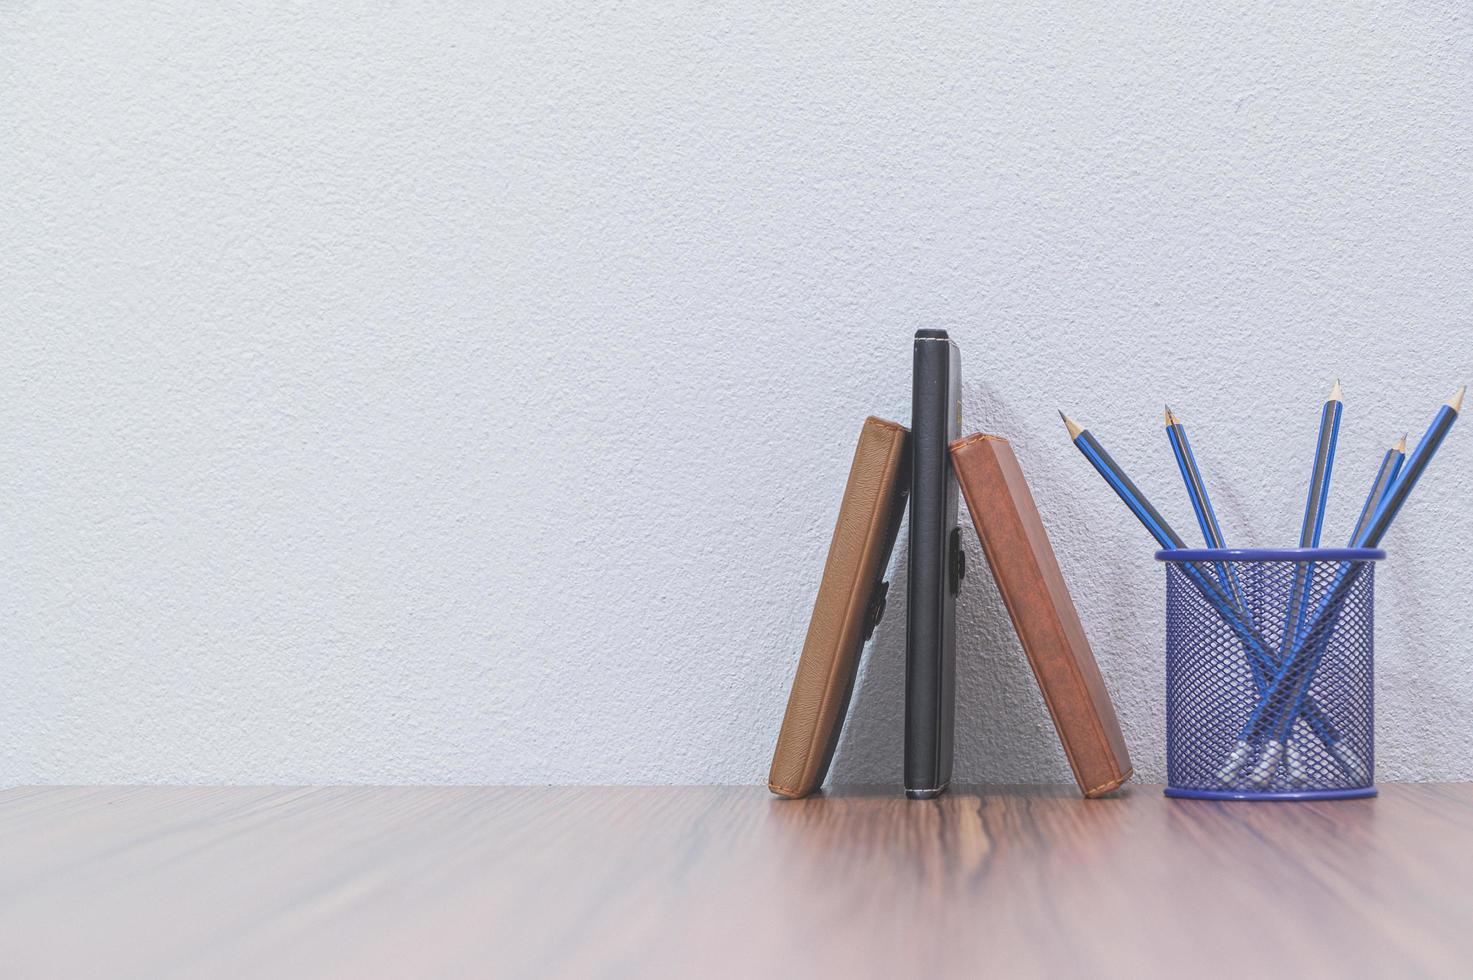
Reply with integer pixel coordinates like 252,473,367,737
906,330,966,800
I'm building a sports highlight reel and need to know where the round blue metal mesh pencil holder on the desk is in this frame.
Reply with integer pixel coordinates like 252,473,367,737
1156,548,1386,800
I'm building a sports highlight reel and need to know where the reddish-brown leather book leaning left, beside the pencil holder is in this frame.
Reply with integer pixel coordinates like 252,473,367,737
952,433,1131,797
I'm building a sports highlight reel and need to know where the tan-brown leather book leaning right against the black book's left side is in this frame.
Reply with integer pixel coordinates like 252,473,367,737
767,416,910,799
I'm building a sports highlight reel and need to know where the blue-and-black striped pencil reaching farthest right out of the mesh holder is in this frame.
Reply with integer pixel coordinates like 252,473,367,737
1240,386,1467,783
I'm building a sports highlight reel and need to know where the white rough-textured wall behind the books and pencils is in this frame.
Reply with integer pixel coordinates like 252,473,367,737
0,1,1473,783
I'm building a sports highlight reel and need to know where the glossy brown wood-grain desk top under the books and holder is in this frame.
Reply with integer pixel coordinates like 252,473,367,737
0,784,1473,980
